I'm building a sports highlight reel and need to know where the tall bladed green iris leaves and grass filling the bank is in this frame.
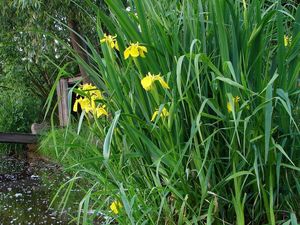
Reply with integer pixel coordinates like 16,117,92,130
35,0,300,225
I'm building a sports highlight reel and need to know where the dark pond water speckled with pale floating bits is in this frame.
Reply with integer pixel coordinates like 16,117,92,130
0,156,73,225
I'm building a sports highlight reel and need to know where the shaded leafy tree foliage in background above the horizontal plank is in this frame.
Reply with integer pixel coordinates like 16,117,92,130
0,0,97,135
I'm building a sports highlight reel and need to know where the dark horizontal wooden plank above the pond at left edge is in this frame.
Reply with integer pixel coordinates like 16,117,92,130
0,132,37,144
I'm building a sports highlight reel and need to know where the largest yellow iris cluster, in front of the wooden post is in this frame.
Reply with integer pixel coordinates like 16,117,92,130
73,84,108,118
